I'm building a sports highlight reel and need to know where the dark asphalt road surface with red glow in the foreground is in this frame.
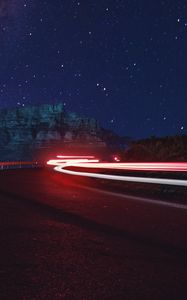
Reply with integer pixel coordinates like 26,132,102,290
0,170,187,300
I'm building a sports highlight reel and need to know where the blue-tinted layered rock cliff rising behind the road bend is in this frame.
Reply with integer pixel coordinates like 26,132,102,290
0,103,105,161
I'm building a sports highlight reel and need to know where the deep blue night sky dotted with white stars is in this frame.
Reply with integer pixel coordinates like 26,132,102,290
0,0,187,138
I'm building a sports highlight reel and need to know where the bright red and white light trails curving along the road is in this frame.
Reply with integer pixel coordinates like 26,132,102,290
47,155,187,186
